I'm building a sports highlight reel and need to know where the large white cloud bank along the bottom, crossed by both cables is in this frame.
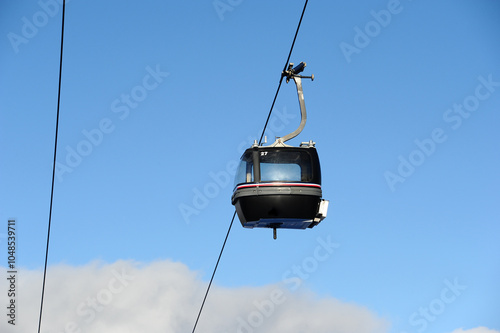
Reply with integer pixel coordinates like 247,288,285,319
0,261,390,333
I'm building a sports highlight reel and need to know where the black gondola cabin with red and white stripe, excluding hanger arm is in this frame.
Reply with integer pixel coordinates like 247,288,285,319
231,141,328,231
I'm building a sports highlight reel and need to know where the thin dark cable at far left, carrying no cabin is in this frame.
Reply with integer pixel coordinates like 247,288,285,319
38,0,66,333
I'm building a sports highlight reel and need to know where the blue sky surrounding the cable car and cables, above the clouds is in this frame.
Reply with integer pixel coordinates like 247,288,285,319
0,0,500,333
